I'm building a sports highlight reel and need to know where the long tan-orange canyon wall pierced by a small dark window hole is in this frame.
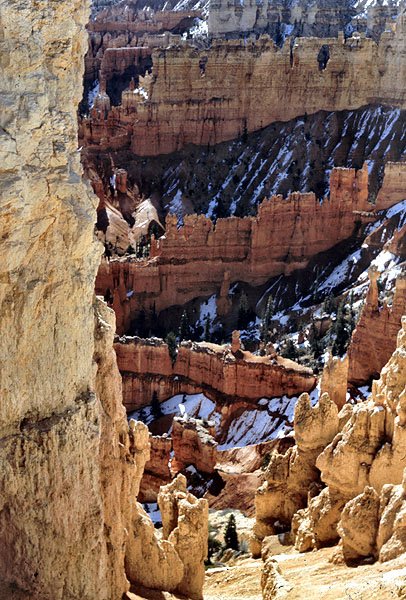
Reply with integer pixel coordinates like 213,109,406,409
81,13,406,156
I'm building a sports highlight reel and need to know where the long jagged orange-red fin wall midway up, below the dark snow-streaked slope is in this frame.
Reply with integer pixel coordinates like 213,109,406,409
96,165,384,334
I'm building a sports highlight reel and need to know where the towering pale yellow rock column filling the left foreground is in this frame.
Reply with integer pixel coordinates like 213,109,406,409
0,0,128,600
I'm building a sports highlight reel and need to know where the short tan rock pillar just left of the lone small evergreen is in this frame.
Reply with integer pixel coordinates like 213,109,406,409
158,475,209,600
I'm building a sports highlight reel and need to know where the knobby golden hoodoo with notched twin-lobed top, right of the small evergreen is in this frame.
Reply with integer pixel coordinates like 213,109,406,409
251,394,338,556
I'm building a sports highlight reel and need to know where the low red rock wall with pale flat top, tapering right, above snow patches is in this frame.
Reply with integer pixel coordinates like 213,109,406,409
114,337,316,411
